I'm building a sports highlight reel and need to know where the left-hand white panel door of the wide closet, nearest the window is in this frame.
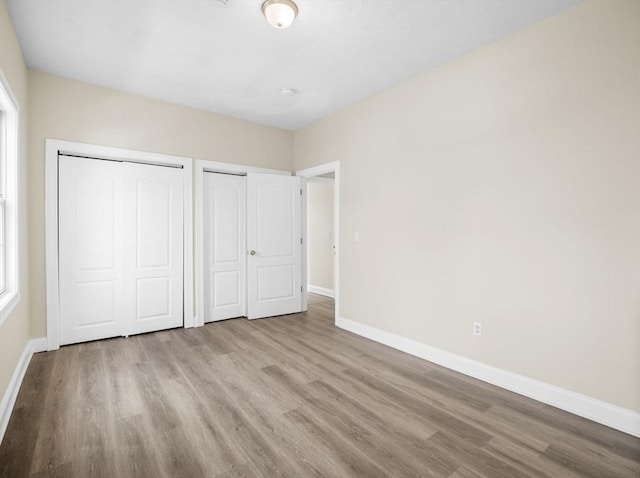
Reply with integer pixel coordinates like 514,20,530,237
58,156,123,345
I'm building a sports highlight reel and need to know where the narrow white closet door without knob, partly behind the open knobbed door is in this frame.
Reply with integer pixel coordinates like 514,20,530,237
203,172,246,322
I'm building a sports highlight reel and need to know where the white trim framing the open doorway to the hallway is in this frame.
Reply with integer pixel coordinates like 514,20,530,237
296,161,340,321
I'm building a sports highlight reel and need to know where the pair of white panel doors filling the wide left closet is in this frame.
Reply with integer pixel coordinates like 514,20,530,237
58,155,184,345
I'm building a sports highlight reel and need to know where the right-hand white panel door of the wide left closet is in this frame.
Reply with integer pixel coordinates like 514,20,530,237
122,163,184,335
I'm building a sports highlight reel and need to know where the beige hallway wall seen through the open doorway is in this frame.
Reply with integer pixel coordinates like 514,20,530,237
307,181,333,290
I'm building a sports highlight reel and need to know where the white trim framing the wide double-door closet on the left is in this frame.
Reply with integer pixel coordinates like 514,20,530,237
45,139,194,350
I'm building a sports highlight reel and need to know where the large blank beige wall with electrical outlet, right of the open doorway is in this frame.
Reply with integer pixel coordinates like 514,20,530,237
295,0,640,411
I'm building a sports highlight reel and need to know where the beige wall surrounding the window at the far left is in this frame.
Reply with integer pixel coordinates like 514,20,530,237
0,0,30,400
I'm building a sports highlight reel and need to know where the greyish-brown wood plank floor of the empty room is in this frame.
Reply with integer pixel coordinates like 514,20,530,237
0,296,640,478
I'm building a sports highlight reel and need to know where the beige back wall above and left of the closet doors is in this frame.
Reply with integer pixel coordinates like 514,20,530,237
29,71,293,336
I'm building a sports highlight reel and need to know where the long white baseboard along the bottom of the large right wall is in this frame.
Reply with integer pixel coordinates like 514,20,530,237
336,317,640,437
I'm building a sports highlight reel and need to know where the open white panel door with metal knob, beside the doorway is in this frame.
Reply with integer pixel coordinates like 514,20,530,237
247,173,302,319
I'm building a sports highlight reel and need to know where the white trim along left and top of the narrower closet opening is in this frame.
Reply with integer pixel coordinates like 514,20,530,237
193,159,291,327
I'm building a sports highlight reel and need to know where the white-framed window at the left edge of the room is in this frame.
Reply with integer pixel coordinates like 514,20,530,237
0,71,20,325
